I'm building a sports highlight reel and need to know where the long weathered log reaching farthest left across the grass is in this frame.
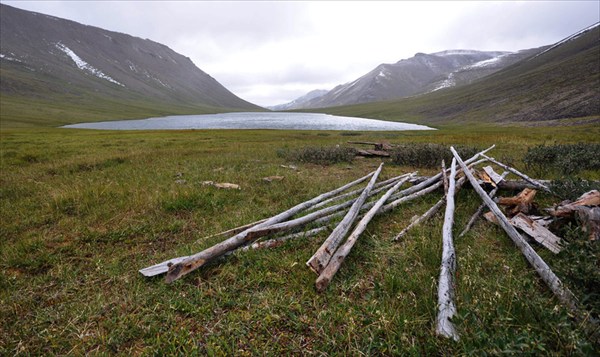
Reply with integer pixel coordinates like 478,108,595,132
140,172,375,283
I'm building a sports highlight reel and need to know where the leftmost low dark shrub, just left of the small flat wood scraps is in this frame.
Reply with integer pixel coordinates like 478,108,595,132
277,146,356,165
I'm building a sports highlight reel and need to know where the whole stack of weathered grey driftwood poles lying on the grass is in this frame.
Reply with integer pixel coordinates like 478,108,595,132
140,146,600,339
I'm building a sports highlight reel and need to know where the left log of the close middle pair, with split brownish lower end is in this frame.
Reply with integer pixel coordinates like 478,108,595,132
306,163,383,274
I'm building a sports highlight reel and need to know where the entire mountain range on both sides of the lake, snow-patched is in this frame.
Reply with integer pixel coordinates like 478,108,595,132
0,4,600,126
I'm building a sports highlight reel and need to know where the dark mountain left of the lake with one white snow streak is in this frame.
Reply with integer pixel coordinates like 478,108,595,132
0,5,260,126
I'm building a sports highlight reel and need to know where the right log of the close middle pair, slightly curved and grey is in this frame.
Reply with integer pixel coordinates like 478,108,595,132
315,174,403,292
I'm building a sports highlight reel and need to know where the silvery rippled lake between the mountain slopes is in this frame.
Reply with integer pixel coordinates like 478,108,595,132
63,112,435,131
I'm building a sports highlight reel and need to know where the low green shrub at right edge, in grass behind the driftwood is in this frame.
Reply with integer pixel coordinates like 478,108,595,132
523,143,600,175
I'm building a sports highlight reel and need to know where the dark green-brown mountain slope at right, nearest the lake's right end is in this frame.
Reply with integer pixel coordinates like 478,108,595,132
319,23,600,125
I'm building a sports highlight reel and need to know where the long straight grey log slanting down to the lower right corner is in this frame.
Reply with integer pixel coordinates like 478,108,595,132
450,147,579,315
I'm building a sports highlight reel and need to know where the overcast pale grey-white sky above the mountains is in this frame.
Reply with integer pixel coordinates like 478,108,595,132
0,0,600,106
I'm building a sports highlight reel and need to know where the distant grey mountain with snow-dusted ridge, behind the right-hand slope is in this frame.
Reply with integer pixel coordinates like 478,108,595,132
297,50,537,108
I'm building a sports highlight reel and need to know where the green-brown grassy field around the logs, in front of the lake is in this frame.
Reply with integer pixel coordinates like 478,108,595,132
0,126,600,356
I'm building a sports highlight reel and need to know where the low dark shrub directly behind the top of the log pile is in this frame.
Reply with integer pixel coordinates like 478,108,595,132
390,144,480,168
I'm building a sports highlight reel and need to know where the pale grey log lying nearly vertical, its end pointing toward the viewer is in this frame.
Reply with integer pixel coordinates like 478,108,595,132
435,159,460,341
